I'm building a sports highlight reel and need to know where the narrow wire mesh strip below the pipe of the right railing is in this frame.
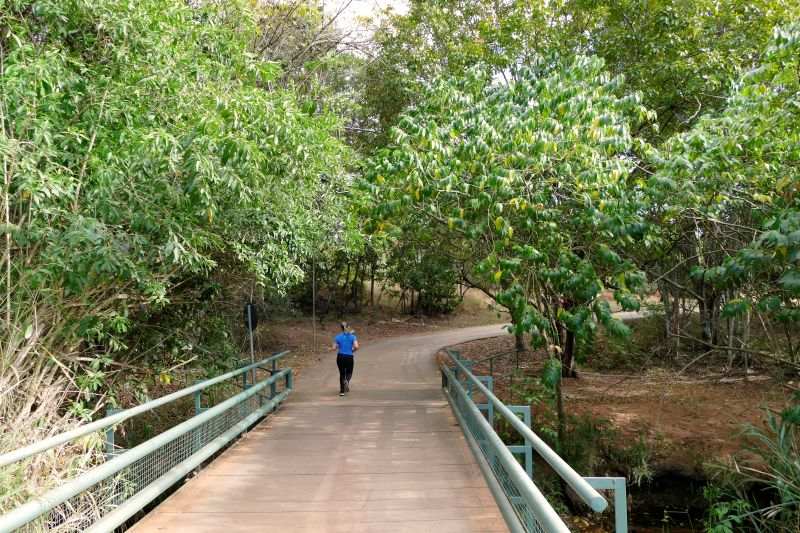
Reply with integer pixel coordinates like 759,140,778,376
446,370,547,533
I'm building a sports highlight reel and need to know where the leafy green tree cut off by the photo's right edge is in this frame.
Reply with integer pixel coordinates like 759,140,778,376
649,24,800,362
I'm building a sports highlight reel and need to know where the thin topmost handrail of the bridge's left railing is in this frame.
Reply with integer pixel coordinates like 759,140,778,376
0,351,289,468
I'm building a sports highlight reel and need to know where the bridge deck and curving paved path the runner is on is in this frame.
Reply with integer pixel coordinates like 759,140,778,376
134,326,507,533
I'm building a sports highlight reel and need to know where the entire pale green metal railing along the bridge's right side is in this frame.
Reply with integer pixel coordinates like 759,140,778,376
441,350,628,533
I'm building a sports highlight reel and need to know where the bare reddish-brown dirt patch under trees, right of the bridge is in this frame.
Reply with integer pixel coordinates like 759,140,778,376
565,371,787,471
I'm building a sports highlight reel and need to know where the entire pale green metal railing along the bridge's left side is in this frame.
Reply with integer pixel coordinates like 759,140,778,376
0,352,293,533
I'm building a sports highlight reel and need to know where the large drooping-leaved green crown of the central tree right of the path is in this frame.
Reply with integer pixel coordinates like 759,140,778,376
365,58,648,366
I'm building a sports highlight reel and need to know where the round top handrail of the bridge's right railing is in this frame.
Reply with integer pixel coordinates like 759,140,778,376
447,350,608,512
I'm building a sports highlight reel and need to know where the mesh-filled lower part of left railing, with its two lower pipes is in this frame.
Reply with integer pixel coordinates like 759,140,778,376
0,356,292,533
